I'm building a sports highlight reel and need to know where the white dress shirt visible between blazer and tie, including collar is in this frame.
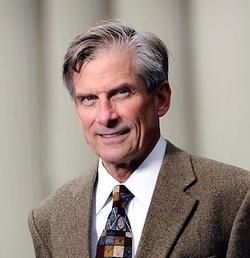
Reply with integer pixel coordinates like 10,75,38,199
91,137,166,258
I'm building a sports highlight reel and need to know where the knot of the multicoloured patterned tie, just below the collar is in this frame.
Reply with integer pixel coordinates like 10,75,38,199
112,185,134,208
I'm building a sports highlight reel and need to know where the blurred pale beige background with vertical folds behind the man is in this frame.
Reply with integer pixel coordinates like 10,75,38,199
0,0,250,258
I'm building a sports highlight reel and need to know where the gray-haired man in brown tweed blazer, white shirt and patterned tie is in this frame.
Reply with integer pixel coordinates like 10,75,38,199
29,22,250,258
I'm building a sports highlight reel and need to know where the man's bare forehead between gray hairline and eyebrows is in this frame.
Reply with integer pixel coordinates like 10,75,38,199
74,49,142,90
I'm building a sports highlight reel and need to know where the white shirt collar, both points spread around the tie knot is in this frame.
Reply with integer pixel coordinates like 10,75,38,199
96,137,167,214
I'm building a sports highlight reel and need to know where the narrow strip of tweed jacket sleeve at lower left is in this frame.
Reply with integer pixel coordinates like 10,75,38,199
28,211,51,258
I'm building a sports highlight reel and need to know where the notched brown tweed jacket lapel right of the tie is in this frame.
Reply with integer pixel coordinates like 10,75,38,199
136,142,198,258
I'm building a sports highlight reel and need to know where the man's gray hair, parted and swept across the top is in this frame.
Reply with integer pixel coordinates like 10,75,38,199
63,21,168,99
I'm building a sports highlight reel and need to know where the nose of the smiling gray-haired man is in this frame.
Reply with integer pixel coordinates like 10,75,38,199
96,98,119,127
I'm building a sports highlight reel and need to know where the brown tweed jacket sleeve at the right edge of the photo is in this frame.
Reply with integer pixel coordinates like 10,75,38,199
226,188,250,258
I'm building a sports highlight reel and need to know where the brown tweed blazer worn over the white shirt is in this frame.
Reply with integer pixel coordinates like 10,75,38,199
29,143,250,258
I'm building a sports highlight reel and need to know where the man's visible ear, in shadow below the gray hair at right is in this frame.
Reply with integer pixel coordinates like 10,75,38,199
155,81,171,117
